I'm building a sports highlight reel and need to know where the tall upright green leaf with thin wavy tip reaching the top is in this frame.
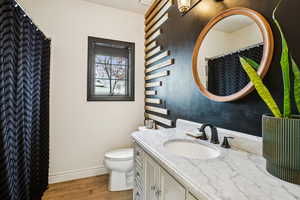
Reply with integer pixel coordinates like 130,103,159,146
273,0,291,117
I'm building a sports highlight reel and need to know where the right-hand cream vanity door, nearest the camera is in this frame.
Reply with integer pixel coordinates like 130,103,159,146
159,168,185,200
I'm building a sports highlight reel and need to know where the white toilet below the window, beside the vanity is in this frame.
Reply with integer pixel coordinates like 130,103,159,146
104,148,133,191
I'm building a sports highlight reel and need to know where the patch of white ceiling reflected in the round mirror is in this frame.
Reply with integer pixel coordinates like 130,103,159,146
214,15,255,33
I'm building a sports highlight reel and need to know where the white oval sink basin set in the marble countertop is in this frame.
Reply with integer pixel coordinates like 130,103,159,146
164,140,220,160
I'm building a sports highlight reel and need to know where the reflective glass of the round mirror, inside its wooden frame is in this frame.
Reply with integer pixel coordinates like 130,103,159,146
197,15,264,96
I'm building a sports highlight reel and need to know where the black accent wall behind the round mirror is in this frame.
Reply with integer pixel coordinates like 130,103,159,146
158,0,300,136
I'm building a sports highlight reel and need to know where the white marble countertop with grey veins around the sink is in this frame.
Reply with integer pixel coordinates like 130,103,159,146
132,129,300,200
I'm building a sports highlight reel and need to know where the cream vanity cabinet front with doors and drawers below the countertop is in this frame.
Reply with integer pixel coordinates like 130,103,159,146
133,144,199,200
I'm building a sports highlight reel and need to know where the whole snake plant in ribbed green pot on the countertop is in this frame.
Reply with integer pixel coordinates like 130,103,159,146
240,0,300,184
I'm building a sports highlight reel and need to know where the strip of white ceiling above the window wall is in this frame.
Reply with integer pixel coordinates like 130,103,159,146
84,0,152,14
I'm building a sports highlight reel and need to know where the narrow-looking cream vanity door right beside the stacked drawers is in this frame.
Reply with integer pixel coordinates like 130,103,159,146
145,155,159,200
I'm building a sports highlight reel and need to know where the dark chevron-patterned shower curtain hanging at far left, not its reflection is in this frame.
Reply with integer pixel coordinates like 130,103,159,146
0,0,50,200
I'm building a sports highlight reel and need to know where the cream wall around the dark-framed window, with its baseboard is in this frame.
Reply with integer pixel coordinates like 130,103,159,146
19,0,144,182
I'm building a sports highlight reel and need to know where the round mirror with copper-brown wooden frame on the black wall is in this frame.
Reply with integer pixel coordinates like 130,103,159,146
193,8,274,102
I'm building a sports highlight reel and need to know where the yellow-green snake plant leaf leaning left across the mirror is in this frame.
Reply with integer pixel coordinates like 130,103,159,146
240,57,282,117
